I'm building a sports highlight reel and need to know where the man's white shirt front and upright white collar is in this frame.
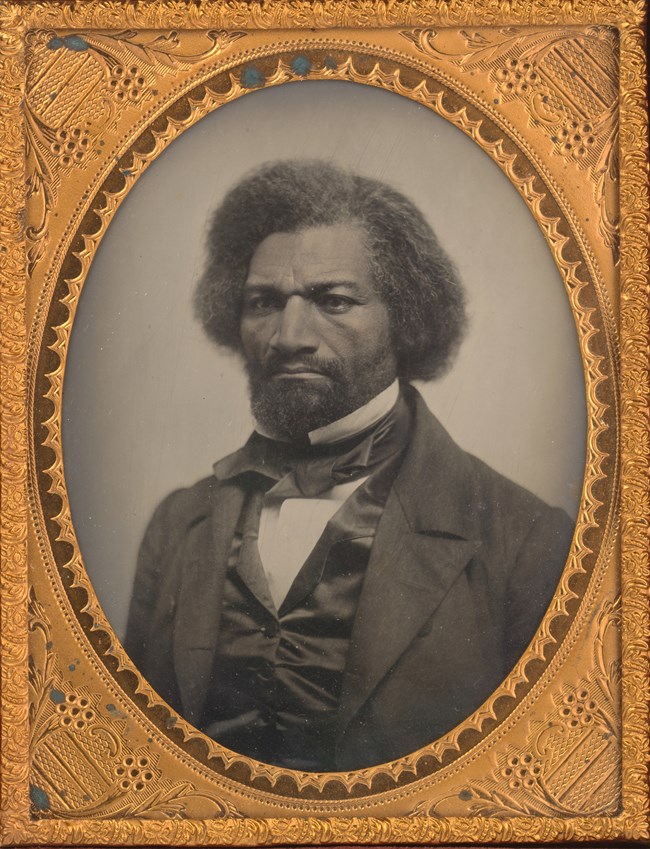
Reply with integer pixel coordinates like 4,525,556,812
257,380,399,608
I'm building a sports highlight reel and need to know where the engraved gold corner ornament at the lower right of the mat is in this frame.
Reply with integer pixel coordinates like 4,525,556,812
414,601,621,817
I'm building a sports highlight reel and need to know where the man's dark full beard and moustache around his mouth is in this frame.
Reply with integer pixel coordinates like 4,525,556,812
247,356,374,441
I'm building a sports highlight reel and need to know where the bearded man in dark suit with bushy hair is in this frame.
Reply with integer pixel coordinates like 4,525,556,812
126,161,572,771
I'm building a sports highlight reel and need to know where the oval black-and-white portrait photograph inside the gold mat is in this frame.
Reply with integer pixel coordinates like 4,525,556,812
63,83,585,772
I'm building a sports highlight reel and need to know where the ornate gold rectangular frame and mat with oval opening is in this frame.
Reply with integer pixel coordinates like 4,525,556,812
0,0,650,845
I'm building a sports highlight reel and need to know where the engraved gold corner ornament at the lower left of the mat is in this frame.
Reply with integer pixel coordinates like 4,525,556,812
29,594,238,819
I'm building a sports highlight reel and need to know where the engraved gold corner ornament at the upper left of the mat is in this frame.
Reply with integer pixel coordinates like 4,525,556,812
25,30,245,273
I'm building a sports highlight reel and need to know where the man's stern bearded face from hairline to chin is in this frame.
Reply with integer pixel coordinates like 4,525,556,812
240,225,396,439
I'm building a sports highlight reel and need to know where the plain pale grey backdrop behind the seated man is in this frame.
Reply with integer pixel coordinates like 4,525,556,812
63,81,586,637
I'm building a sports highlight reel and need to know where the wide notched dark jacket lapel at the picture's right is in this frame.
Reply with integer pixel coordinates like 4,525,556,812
338,388,481,733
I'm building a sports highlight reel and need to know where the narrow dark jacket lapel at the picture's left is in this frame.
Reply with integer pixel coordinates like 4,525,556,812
174,481,245,725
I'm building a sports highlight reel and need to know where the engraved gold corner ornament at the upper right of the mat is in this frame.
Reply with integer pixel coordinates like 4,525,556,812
403,26,618,256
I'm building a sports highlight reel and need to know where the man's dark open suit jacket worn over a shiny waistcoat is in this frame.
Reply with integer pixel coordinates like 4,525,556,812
125,388,572,770
